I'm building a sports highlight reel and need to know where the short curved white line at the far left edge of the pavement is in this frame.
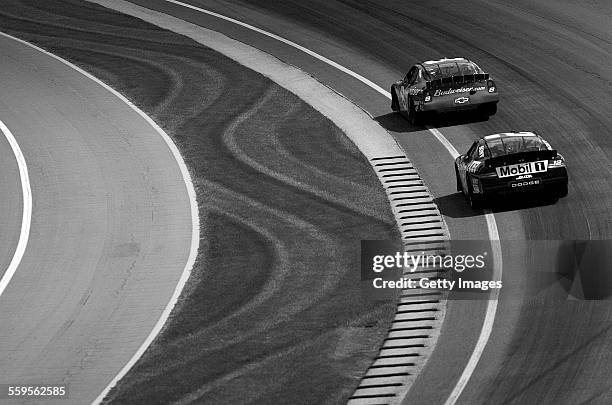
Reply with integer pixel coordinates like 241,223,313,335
0,121,32,295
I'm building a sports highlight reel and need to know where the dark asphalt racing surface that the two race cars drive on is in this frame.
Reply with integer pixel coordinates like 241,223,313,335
119,0,612,404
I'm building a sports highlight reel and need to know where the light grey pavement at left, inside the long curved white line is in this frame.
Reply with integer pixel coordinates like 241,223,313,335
0,29,192,404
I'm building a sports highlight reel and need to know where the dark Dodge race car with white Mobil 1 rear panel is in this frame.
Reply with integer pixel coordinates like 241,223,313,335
455,132,567,208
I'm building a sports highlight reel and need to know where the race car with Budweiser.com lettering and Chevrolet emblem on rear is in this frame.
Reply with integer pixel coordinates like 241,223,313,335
391,58,499,125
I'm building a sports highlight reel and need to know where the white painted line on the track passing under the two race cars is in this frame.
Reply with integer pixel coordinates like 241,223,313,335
157,0,503,405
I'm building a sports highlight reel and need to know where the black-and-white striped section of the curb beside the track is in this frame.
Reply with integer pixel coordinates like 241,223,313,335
348,153,450,405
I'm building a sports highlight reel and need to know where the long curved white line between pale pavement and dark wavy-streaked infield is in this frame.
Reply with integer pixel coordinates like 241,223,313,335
0,32,200,404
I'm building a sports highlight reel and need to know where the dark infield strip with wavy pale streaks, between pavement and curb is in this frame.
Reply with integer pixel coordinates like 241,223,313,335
0,0,399,404
